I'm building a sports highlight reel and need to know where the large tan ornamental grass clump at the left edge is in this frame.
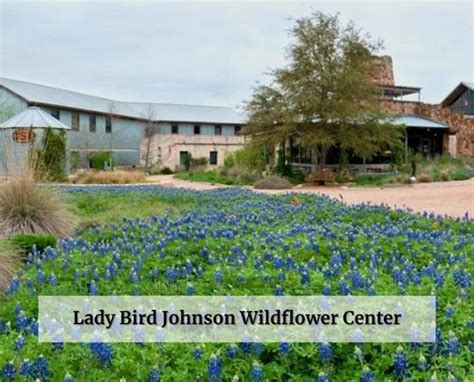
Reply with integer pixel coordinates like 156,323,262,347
0,175,75,237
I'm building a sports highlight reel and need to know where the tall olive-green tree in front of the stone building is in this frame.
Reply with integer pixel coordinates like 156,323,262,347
246,12,401,164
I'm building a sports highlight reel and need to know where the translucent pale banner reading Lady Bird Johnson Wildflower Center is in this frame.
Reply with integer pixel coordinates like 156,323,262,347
39,296,436,342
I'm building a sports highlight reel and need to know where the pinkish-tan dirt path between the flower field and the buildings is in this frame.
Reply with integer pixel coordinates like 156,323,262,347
148,175,474,217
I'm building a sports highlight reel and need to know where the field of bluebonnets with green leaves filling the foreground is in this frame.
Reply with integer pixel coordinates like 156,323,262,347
0,186,474,382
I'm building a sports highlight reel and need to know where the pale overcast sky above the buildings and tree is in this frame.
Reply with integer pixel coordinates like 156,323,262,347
0,0,474,106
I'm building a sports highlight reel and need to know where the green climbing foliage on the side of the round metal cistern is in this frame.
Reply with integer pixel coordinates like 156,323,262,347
38,127,66,181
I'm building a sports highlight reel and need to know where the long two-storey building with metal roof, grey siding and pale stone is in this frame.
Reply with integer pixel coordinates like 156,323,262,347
0,78,245,170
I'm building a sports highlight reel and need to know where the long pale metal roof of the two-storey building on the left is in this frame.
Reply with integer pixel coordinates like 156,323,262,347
0,78,246,124
